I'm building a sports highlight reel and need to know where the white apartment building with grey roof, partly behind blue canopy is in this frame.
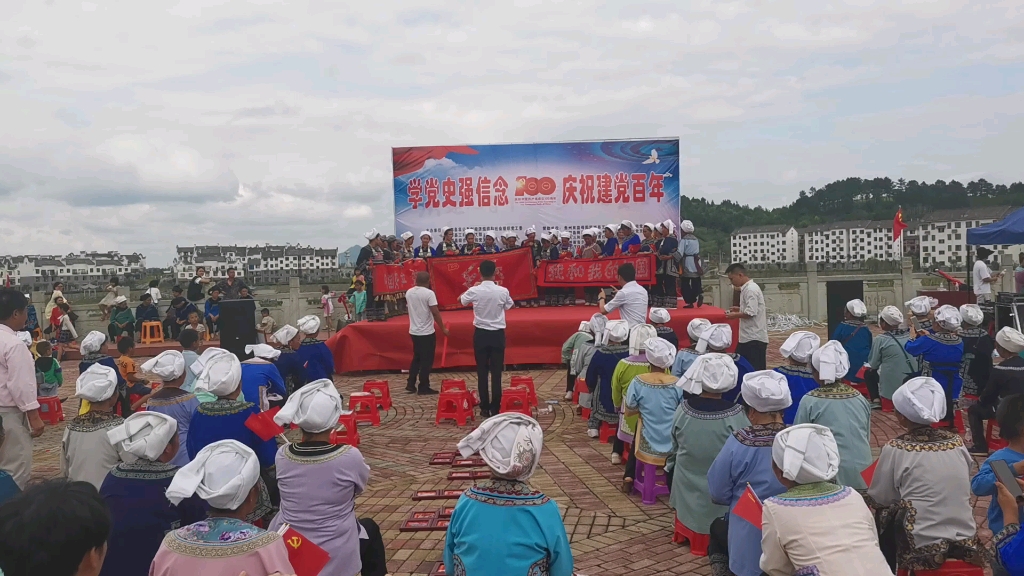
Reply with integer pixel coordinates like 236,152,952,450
911,206,1024,269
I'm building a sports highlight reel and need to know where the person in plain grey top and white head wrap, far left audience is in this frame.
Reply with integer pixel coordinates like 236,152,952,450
60,364,135,490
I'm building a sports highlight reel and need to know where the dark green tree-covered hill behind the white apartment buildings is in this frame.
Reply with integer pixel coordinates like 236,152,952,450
681,177,1024,259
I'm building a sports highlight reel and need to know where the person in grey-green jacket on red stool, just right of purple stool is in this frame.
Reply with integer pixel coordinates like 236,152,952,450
665,353,751,551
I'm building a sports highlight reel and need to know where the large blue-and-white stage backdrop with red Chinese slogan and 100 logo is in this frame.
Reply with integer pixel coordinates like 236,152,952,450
392,138,680,239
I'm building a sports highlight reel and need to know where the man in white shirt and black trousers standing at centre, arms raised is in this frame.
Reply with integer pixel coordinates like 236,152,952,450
459,260,515,412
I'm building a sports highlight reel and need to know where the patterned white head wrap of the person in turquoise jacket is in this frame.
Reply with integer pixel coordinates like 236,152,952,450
459,412,544,481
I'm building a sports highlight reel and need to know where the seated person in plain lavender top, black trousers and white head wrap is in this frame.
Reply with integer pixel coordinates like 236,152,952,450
270,379,387,576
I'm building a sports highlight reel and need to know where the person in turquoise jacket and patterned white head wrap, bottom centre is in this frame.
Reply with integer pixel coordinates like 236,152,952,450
443,414,573,576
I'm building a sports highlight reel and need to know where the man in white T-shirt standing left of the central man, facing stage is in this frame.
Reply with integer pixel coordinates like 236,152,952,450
406,272,449,396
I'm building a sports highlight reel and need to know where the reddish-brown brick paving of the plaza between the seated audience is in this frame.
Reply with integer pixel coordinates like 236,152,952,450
33,329,991,576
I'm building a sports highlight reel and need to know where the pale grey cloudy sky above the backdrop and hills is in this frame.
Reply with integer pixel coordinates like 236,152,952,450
0,0,1024,265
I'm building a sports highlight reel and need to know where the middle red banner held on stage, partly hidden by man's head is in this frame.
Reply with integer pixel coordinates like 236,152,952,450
428,249,537,310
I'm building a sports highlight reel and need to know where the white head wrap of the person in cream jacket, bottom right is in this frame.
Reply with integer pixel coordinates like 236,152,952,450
771,424,839,484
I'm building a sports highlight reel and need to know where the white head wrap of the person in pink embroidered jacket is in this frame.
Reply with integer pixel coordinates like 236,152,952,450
166,440,259,510
